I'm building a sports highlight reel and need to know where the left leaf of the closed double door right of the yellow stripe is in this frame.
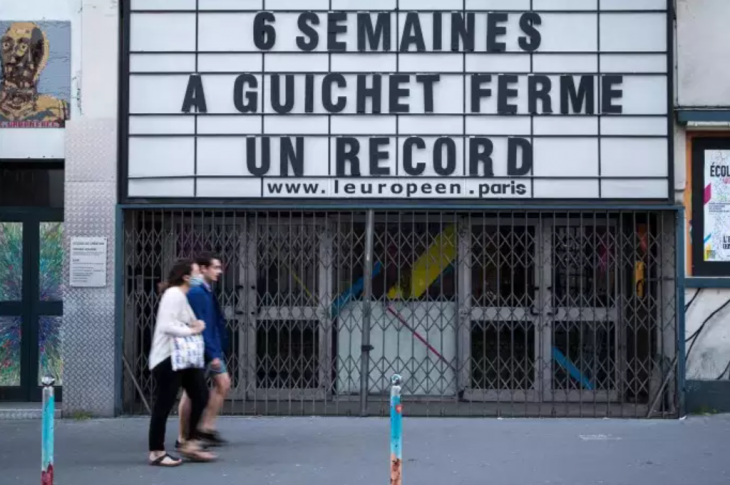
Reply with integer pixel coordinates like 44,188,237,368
461,218,541,401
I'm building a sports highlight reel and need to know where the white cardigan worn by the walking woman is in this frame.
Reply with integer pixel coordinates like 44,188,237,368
149,286,197,370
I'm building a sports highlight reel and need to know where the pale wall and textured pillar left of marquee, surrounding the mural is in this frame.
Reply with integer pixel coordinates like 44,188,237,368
0,0,119,416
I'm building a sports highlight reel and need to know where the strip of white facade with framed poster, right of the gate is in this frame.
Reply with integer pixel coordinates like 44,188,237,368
676,0,730,412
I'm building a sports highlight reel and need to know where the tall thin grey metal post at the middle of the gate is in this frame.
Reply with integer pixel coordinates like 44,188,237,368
360,210,375,416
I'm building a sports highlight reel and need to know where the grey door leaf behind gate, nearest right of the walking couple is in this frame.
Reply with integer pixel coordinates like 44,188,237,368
246,218,332,400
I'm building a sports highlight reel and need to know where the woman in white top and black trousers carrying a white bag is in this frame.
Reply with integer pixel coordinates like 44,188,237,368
149,260,216,467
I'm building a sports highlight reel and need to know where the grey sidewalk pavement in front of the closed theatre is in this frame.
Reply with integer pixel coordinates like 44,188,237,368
0,416,730,485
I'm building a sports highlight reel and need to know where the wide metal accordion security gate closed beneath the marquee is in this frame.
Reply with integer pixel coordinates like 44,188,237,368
121,209,679,417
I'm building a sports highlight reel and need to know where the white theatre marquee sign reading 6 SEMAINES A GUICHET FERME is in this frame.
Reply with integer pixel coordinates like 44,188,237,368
124,0,671,200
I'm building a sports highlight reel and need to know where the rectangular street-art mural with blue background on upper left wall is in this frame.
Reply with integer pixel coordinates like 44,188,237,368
0,21,71,128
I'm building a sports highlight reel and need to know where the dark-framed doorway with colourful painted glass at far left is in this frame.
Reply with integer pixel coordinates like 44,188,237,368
0,163,64,402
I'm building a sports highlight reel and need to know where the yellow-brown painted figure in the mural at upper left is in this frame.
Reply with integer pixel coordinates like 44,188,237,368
0,22,69,127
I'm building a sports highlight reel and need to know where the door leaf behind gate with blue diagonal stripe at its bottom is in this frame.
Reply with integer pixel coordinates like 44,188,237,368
542,218,625,402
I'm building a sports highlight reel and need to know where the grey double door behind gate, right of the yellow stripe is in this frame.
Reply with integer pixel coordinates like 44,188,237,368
460,217,622,402
